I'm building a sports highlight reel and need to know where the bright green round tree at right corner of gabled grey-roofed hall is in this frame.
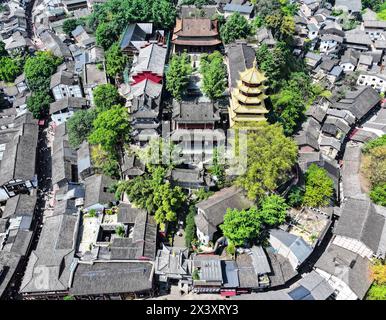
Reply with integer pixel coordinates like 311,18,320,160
220,208,261,246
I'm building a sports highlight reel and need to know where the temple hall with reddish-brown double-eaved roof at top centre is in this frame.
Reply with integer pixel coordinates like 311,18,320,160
172,19,221,53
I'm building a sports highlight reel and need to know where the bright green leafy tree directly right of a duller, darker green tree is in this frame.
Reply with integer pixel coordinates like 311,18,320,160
88,105,130,153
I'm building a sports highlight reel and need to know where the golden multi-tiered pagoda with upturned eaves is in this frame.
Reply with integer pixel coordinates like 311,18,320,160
229,61,268,128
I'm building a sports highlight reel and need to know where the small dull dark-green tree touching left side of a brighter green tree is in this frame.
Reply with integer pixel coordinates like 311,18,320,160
67,109,97,148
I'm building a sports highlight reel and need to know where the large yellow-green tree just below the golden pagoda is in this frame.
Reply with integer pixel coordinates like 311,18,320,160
236,122,297,200
